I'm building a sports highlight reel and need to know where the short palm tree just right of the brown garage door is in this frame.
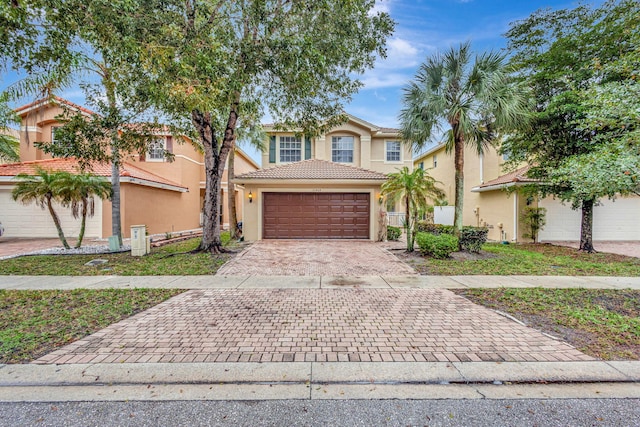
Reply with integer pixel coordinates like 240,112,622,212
381,166,444,252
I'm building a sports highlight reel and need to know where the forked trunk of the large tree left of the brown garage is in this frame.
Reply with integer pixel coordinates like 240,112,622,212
191,94,240,253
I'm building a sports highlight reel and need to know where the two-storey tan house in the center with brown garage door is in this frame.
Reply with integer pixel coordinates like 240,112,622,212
236,115,413,240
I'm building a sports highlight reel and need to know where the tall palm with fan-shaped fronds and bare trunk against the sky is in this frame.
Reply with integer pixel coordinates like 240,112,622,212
400,43,527,234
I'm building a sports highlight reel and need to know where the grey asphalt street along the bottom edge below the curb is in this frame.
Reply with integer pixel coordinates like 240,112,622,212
0,399,640,427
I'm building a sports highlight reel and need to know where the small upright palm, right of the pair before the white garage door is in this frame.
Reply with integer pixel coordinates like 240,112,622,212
55,172,111,248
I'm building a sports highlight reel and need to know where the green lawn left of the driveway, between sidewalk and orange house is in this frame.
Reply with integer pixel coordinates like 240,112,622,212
0,233,235,276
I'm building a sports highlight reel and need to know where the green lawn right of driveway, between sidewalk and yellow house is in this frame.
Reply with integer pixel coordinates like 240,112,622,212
405,244,640,276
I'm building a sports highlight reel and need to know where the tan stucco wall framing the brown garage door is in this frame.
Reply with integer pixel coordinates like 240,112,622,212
242,183,381,241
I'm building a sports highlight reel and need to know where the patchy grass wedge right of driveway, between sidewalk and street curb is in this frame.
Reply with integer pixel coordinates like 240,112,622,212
454,288,640,360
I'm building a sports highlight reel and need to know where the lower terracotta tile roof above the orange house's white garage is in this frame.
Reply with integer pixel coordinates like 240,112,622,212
0,157,189,193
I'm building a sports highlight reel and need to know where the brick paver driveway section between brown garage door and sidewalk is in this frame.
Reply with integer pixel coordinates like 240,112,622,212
217,240,416,276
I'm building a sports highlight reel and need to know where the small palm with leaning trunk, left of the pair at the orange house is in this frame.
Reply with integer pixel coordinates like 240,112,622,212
11,168,70,249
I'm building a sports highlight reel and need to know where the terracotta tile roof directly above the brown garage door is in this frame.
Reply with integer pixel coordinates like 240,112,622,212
236,159,387,180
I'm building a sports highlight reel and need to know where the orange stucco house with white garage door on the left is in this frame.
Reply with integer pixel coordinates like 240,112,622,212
0,98,258,238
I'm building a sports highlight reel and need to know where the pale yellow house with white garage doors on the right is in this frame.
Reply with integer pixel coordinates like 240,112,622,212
414,144,640,242
